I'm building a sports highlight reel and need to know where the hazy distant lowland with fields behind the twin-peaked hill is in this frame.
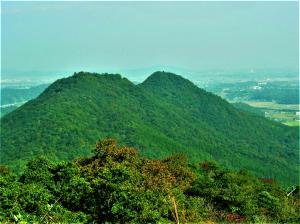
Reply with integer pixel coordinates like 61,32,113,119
1,68,300,126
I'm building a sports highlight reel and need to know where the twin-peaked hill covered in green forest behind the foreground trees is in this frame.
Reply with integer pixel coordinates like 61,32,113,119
0,72,299,184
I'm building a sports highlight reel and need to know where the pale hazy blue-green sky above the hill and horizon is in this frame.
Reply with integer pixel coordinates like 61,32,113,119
1,2,299,77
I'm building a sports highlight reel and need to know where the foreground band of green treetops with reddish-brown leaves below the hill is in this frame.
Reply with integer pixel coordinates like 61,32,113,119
0,139,300,223
